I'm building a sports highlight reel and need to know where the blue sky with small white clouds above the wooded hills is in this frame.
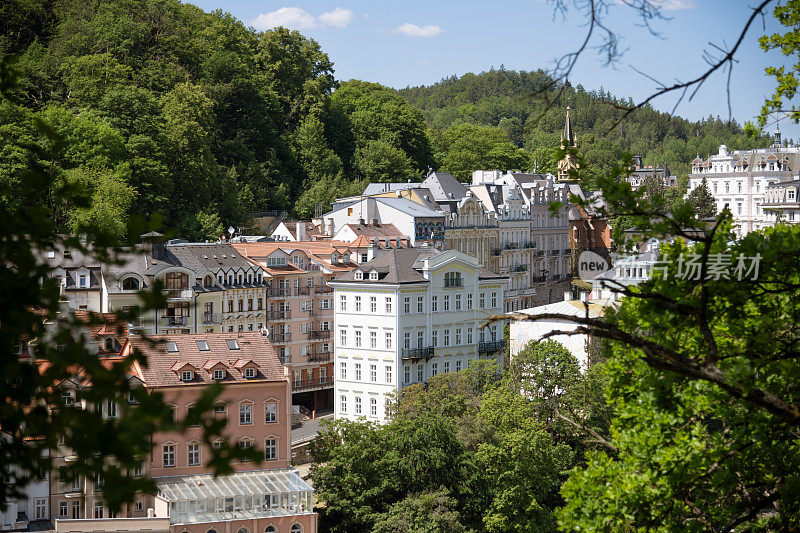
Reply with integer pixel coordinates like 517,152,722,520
192,0,800,141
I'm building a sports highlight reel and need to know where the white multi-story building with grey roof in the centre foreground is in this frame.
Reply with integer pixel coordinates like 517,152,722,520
329,247,507,422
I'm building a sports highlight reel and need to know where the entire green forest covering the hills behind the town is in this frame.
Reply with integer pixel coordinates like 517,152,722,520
0,0,776,239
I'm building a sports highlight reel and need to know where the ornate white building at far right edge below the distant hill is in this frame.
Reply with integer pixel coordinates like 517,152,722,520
687,131,800,236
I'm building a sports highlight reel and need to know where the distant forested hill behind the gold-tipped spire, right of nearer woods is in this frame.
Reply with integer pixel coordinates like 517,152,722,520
399,68,765,182
